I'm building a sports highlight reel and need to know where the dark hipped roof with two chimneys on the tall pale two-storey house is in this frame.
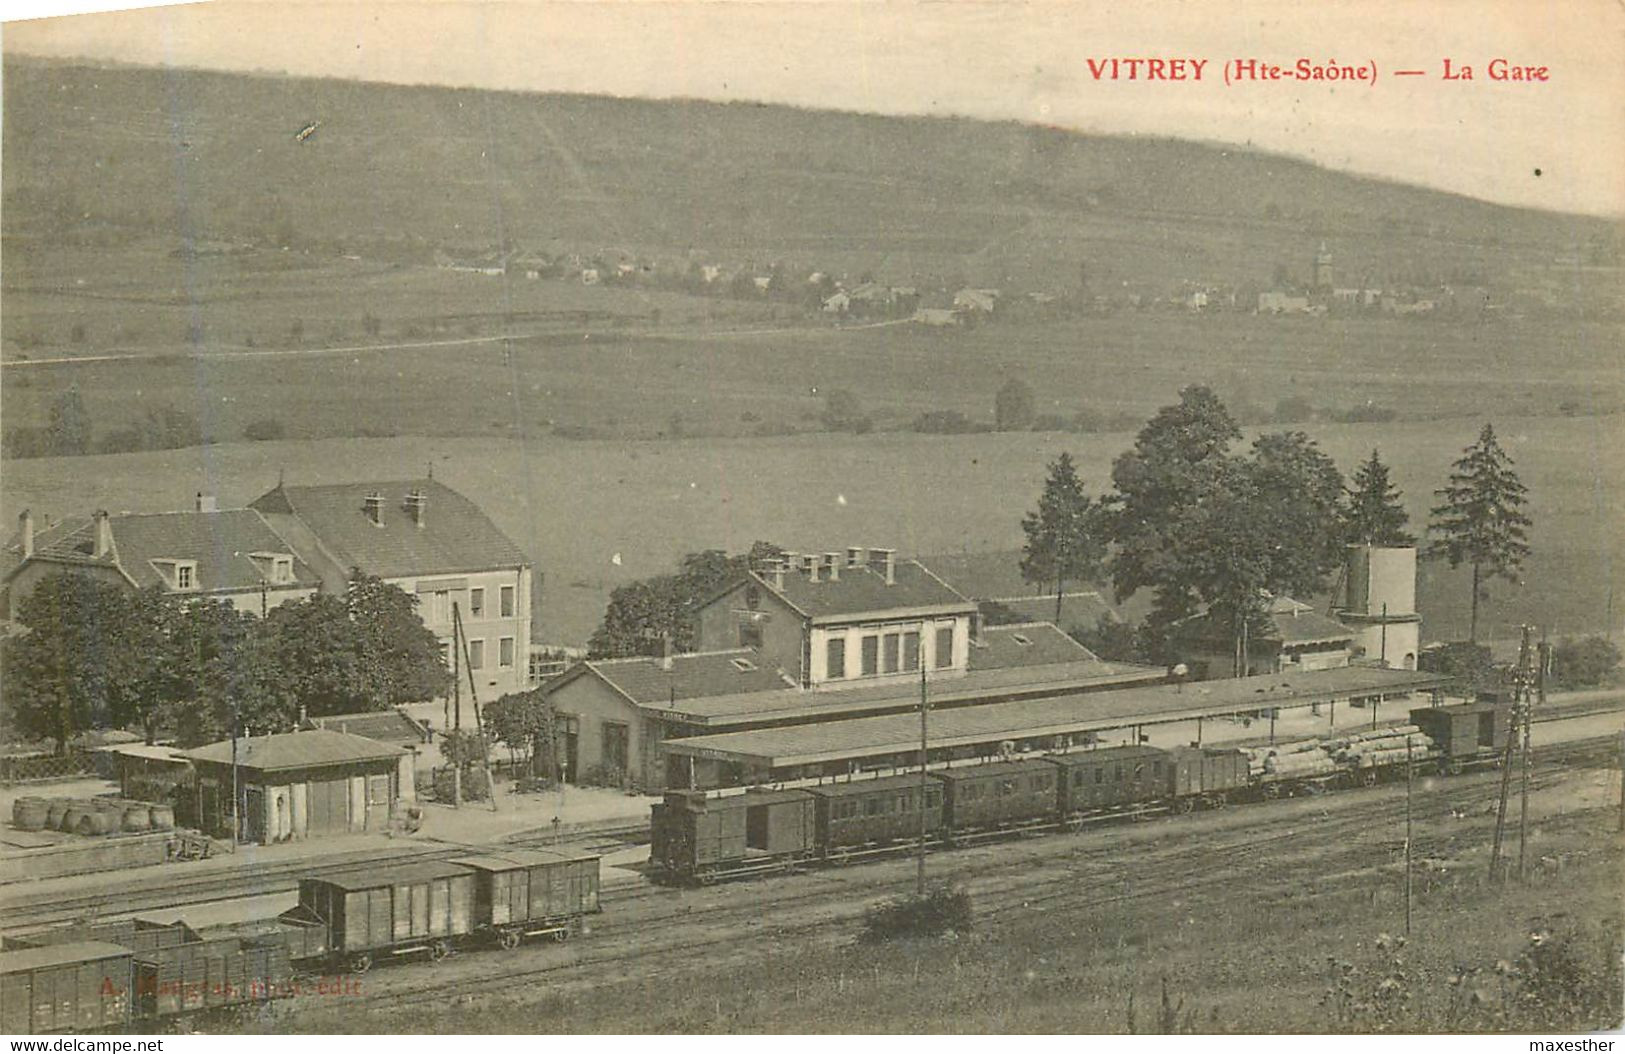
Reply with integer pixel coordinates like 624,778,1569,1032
250,479,530,578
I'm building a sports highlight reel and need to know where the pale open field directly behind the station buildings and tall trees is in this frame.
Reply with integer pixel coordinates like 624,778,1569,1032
0,410,1625,643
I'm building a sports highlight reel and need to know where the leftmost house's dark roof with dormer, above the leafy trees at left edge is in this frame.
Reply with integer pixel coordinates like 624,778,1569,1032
7,508,320,593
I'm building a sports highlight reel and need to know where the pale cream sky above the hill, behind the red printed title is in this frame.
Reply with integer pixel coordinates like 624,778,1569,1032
3,0,1625,216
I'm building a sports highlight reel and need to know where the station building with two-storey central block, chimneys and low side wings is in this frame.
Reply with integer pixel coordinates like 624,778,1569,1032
546,547,1167,791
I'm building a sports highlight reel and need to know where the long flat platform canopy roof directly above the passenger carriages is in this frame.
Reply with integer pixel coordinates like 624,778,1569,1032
661,666,1450,770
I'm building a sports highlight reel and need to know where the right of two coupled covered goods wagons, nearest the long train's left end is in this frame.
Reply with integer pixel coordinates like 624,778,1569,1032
453,849,601,950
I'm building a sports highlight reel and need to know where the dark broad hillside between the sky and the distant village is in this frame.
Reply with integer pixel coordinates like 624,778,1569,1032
3,57,1617,291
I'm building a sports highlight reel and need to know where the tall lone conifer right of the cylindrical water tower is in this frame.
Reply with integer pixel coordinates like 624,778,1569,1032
1427,424,1532,641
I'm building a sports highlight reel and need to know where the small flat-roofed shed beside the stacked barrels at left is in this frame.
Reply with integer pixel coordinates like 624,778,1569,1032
184,729,406,844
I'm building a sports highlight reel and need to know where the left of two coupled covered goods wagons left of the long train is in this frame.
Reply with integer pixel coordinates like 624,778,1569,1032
286,861,475,973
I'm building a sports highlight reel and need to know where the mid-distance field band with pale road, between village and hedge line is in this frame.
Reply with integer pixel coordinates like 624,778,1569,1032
0,289,1625,440
